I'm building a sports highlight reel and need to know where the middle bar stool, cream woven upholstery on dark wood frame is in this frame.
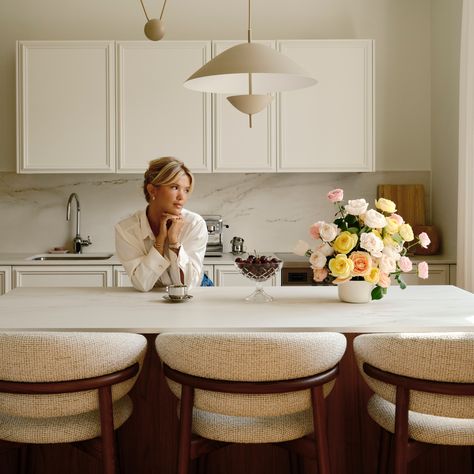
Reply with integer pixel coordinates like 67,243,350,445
156,332,346,474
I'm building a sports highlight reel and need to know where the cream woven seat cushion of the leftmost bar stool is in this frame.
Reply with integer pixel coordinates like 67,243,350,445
0,395,132,442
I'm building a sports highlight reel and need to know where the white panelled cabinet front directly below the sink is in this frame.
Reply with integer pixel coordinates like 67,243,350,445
12,265,112,288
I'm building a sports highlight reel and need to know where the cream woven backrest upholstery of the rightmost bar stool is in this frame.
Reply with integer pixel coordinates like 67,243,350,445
354,333,474,418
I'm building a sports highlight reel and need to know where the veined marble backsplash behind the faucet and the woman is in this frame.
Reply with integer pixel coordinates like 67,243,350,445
0,171,430,253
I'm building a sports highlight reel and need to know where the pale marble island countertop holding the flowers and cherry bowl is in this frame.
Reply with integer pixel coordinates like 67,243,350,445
0,285,474,333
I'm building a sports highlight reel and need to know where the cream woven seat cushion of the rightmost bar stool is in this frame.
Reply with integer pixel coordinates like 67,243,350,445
367,395,474,446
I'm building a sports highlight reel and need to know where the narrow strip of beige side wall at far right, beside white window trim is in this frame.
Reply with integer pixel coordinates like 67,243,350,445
431,0,462,255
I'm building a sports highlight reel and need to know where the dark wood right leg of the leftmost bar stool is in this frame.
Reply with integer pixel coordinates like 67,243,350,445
99,386,115,474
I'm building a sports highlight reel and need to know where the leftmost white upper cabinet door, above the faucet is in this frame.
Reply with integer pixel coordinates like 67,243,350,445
17,41,115,173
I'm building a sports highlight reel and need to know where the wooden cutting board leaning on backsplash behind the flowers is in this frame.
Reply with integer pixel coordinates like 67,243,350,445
377,184,426,225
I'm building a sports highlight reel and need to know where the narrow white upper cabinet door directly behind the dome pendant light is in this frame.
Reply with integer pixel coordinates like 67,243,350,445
213,41,276,173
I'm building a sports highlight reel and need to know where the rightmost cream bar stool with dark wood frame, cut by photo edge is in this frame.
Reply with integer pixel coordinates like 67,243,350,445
354,333,474,474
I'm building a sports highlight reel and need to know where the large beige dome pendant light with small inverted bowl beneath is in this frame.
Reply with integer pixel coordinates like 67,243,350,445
184,0,317,127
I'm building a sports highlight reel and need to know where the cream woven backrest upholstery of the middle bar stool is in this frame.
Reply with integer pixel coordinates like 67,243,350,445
156,333,346,417
